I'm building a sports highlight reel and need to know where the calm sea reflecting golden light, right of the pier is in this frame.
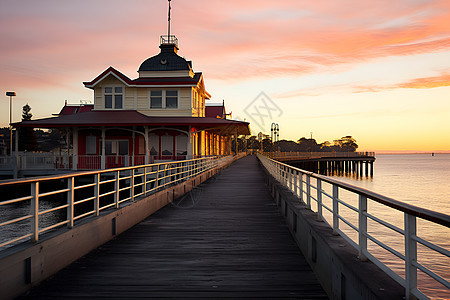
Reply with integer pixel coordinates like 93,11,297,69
326,154,450,299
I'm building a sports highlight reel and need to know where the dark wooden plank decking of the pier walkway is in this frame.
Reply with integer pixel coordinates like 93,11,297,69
21,156,327,299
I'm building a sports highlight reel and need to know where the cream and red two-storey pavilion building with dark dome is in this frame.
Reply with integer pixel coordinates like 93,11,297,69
13,36,250,170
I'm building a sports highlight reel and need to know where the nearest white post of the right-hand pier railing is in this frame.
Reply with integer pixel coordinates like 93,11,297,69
405,213,417,300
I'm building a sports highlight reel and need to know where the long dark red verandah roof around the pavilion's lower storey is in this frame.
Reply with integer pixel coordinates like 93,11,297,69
12,110,250,135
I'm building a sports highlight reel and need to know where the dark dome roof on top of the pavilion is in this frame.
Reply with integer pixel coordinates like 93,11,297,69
138,45,191,72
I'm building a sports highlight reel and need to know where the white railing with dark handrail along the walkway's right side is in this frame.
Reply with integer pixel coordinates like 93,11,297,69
258,154,450,299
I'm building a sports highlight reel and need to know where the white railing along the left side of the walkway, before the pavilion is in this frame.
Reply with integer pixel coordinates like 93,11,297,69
0,154,232,251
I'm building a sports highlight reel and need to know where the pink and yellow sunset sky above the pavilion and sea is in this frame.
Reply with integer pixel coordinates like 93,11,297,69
0,0,450,151
